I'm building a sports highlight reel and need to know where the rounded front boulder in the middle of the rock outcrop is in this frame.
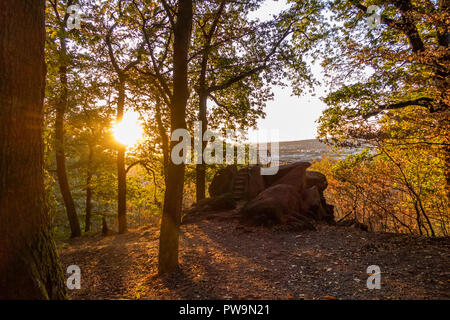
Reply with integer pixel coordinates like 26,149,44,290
241,184,301,227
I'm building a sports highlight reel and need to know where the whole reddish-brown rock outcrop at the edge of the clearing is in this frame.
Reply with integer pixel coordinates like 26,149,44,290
186,162,334,230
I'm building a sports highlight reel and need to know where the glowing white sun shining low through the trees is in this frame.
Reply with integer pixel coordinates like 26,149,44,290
113,111,143,146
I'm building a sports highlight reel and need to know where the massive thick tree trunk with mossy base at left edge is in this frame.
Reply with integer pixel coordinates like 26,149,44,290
0,0,66,299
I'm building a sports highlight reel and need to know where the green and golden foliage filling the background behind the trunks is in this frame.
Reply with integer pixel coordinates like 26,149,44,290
44,0,450,238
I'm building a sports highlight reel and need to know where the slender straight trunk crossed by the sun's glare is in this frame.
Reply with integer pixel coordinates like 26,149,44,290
117,81,127,233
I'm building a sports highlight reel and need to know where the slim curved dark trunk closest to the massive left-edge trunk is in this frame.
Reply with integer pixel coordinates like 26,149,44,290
55,37,81,238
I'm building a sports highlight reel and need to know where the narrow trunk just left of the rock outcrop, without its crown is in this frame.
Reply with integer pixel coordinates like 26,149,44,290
195,90,208,202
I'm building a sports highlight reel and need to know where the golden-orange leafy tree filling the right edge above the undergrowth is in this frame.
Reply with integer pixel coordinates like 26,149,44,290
318,0,450,236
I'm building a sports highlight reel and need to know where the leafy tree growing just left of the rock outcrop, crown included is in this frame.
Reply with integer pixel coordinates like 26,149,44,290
190,0,321,201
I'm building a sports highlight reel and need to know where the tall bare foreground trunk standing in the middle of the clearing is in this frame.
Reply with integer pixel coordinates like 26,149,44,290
158,0,192,274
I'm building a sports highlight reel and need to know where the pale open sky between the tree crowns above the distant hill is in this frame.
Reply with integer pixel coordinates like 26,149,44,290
244,0,326,141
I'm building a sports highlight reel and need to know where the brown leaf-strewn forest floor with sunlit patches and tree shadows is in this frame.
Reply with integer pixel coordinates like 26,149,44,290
58,220,450,299
